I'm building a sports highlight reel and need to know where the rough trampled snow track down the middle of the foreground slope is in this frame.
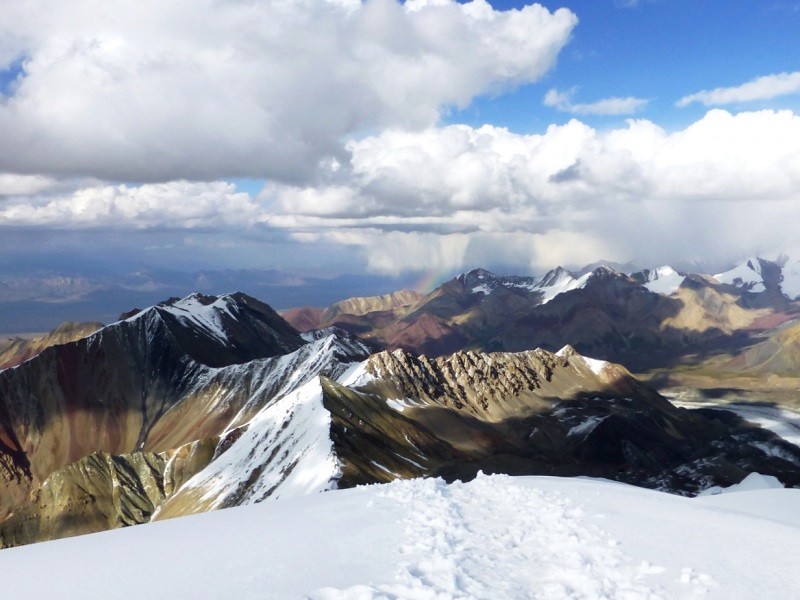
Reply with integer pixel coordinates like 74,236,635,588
310,476,663,600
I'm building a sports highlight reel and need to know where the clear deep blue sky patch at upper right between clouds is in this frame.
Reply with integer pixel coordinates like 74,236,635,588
447,0,800,133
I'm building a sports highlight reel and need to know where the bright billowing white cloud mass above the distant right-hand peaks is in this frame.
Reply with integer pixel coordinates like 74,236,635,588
265,109,800,273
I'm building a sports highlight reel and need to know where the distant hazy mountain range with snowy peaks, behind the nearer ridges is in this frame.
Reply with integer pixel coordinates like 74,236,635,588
287,262,797,370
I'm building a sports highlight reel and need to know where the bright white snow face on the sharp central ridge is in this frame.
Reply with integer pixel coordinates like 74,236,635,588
155,335,370,508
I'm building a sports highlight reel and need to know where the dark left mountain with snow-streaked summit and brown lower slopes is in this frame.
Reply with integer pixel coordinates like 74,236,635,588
0,295,306,518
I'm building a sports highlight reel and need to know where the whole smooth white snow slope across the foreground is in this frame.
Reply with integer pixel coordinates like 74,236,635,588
0,475,800,599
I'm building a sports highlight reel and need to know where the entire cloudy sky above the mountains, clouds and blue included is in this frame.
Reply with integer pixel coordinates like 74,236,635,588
0,0,800,298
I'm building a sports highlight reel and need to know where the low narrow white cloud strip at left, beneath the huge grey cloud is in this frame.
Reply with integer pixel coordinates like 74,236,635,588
0,181,261,230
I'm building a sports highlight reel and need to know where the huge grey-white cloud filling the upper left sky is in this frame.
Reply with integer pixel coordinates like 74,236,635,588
0,0,577,182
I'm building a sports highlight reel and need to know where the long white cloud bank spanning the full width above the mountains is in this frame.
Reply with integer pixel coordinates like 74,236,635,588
0,109,800,274
